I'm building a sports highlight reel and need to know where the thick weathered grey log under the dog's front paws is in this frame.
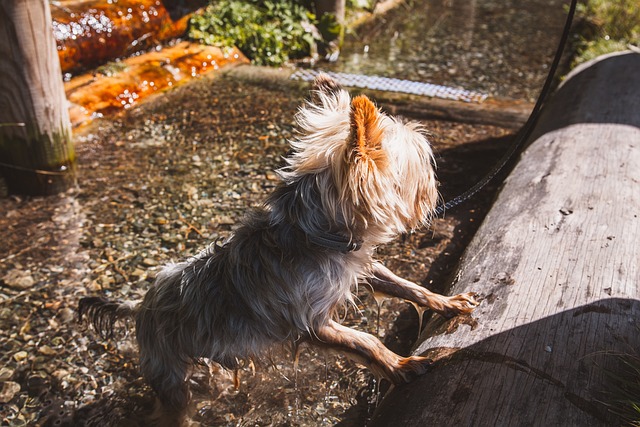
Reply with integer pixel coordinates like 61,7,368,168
372,53,640,426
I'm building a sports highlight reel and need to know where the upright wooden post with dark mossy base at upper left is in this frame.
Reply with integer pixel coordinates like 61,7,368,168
0,0,75,195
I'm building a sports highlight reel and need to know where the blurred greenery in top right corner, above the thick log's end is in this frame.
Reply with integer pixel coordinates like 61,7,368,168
575,0,640,64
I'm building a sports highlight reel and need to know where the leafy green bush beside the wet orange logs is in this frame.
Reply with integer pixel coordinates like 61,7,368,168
189,0,319,66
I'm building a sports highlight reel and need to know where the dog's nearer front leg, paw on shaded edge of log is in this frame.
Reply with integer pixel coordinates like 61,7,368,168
311,321,431,384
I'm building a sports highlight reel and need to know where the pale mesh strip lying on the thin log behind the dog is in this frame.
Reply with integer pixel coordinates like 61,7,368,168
291,69,488,103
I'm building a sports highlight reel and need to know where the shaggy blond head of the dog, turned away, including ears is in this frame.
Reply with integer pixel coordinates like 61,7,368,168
280,75,438,243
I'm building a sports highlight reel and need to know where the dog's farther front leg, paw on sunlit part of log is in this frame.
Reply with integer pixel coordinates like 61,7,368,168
367,262,478,318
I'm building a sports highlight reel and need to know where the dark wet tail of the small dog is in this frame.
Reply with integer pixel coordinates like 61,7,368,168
78,297,138,338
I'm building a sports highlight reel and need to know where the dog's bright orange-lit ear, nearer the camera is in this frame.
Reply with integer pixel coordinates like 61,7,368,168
349,95,386,167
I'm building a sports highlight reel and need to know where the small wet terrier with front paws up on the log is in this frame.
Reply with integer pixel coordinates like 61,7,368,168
78,75,477,417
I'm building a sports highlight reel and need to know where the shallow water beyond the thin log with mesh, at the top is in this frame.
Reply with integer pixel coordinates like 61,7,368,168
330,0,566,101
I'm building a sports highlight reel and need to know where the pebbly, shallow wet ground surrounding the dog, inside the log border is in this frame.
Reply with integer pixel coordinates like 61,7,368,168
0,72,512,426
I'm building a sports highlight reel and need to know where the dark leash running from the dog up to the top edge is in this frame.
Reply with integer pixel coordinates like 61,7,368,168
433,0,578,217
